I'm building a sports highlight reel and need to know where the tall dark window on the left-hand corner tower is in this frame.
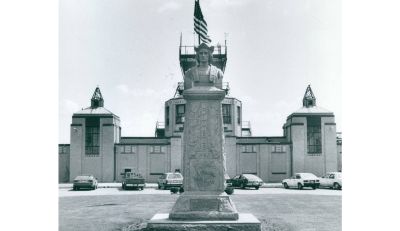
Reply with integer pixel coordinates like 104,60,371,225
85,117,100,155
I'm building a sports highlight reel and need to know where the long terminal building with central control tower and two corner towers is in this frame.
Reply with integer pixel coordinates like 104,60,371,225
59,45,342,182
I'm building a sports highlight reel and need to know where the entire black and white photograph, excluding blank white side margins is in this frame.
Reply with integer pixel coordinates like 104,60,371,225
58,0,342,231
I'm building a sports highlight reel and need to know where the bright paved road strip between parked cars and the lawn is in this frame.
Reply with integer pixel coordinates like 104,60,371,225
58,188,342,197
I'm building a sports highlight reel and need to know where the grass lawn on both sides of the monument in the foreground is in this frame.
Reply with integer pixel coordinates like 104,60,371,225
59,194,342,231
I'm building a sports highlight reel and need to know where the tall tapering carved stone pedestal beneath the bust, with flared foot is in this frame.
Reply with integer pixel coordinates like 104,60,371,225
169,86,238,220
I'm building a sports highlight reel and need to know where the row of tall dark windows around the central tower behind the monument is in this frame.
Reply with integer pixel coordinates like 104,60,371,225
165,104,241,126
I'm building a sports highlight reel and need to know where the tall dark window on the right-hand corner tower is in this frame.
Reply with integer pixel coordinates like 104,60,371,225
307,116,322,154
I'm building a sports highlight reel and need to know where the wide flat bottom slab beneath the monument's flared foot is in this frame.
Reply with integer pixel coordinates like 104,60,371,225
146,213,261,231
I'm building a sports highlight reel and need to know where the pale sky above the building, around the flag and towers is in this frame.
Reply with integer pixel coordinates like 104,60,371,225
59,0,342,143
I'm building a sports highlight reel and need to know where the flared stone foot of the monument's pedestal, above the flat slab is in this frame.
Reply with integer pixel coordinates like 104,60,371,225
169,191,239,220
